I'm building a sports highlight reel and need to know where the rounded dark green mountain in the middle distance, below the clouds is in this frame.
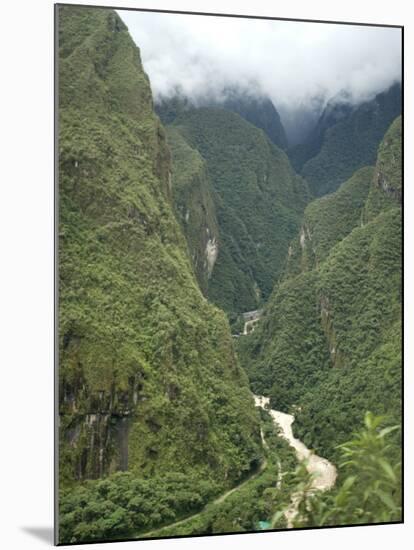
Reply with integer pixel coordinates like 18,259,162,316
169,108,308,314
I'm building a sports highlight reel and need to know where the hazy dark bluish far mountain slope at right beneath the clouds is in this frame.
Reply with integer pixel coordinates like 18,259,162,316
292,84,401,197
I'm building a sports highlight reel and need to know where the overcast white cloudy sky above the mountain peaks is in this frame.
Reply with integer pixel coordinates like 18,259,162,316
118,11,401,109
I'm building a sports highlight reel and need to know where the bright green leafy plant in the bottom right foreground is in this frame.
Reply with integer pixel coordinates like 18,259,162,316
294,412,402,527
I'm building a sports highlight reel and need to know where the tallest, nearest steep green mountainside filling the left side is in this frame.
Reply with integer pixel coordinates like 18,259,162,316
59,6,261,520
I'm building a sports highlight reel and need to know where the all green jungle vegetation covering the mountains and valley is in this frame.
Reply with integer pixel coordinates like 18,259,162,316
58,6,402,543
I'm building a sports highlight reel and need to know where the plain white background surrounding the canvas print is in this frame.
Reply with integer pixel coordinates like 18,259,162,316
0,0,414,550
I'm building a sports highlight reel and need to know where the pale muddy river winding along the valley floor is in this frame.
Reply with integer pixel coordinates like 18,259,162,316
253,395,337,528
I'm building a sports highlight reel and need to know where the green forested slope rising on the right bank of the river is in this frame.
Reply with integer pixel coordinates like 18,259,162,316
239,118,401,457
